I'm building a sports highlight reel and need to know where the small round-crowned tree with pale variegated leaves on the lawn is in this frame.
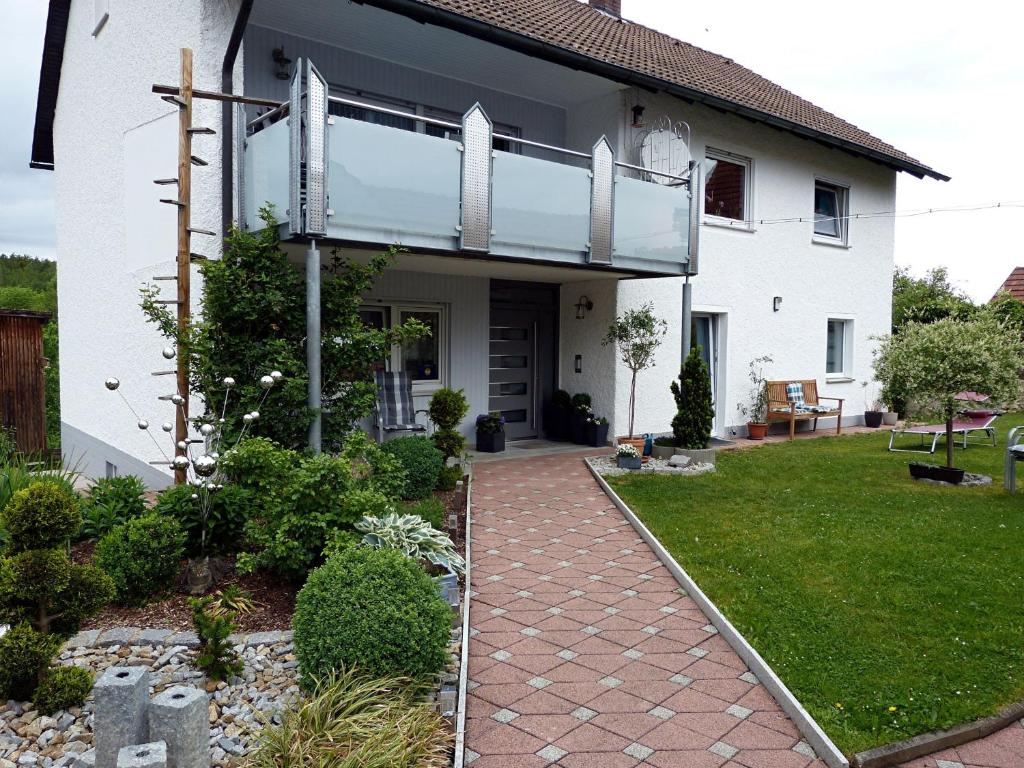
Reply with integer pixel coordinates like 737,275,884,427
874,314,1024,468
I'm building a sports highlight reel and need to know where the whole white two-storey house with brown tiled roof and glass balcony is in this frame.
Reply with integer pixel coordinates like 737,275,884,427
32,0,946,483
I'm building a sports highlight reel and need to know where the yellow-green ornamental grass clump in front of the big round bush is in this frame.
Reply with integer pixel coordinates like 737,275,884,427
243,670,452,768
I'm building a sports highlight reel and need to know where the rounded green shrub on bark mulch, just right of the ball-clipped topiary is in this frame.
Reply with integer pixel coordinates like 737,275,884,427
93,514,185,605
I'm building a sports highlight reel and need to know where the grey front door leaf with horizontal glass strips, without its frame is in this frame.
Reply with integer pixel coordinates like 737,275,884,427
487,307,540,440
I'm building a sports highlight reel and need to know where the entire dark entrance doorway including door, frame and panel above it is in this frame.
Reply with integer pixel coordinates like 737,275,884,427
488,281,558,440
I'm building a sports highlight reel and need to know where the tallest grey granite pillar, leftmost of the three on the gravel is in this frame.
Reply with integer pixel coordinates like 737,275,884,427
92,667,150,768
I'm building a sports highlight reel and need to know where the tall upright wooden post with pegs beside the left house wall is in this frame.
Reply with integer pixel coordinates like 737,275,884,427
174,48,193,485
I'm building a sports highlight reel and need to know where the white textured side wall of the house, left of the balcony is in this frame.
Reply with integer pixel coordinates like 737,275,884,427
54,0,241,480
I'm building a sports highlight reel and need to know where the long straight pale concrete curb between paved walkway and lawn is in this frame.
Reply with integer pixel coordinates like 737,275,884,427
585,459,850,768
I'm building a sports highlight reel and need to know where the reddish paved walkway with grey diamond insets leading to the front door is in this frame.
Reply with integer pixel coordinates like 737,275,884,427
466,454,824,768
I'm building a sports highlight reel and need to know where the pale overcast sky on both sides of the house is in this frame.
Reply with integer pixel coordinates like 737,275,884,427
0,0,1024,301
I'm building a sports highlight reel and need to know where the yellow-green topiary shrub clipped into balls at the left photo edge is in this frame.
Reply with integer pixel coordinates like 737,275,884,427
0,481,114,703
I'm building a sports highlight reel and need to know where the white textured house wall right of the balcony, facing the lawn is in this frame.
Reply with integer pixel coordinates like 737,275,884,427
615,96,896,432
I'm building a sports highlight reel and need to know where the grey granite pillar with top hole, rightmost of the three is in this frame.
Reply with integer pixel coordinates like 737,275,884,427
150,685,210,768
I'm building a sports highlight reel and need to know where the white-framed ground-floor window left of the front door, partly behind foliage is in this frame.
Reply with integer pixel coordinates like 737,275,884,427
359,303,447,385
